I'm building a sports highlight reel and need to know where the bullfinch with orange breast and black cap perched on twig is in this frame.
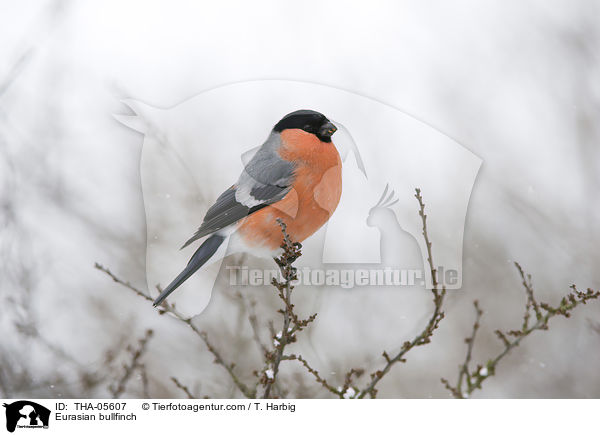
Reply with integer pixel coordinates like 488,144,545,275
154,110,342,306
